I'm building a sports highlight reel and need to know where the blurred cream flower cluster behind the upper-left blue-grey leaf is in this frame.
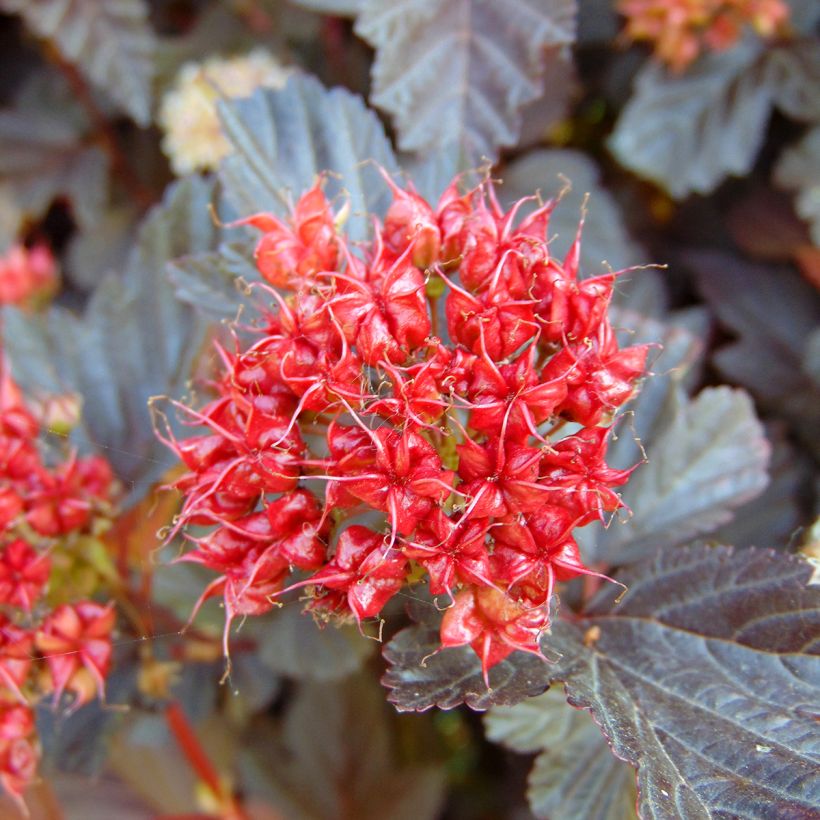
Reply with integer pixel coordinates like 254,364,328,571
159,49,290,174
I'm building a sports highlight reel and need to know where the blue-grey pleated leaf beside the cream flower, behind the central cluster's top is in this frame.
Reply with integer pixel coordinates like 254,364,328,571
219,74,396,240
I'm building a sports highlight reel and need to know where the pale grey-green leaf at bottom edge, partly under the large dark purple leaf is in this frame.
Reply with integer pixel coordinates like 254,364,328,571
484,687,637,820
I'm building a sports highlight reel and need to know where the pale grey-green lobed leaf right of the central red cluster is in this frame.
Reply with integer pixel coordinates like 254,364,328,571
576,300,770,565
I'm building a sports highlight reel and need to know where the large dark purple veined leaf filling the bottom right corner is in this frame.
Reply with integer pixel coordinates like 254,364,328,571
545,547,820,820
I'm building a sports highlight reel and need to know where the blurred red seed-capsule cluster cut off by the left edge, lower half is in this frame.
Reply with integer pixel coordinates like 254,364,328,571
0,373,114,800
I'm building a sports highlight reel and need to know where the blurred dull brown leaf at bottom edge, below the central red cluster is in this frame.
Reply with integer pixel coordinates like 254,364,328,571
240,677,444,820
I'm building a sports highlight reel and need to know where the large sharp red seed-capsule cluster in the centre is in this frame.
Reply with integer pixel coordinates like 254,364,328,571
163,175,647,678
